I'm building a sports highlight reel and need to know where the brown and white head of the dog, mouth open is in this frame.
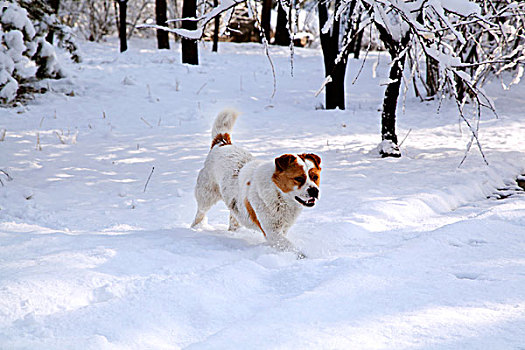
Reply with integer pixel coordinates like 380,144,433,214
272,153,321,207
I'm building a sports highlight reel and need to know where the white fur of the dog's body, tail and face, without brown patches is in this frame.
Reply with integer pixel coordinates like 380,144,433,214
192,110,317,257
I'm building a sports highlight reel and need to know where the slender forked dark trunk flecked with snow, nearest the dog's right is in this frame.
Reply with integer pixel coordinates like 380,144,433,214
376,23,410,157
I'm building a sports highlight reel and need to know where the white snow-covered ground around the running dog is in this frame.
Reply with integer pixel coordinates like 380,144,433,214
0,40,525,350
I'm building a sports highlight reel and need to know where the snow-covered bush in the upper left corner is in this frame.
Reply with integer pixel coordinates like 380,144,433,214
0,0,79,103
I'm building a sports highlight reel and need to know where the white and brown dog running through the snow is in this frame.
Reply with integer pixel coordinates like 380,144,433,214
191,109,321,258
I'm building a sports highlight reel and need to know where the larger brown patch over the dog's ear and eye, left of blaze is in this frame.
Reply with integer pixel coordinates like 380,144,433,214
272,154,306,193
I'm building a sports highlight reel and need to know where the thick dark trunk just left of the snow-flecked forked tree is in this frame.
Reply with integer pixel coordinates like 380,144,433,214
318,0,347,109
